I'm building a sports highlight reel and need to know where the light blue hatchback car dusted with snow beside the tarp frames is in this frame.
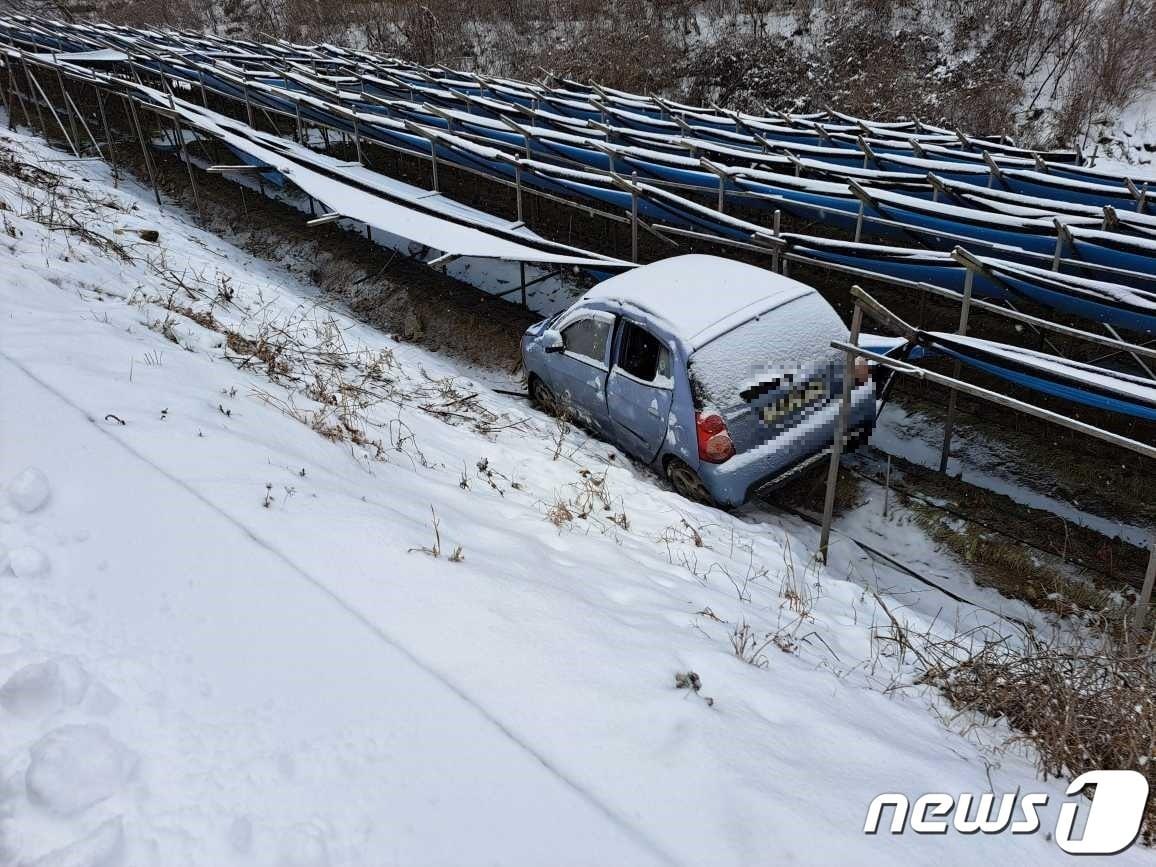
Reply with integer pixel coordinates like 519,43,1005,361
521,255,875,506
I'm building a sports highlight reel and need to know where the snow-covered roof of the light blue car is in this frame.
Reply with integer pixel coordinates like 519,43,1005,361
584,254,815,349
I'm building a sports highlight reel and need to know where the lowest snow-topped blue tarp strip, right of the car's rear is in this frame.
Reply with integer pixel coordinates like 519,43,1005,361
919,332,1156,421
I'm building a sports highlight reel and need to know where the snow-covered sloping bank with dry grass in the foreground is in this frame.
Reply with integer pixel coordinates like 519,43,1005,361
0,123,1150,867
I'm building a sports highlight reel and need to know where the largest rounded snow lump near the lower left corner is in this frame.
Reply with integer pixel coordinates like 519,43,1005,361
25,725,136,815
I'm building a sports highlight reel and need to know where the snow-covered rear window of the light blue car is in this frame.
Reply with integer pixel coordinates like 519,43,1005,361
690,292,847,410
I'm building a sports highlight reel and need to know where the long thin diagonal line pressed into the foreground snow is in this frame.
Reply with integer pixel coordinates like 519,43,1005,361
0,351,681,865
